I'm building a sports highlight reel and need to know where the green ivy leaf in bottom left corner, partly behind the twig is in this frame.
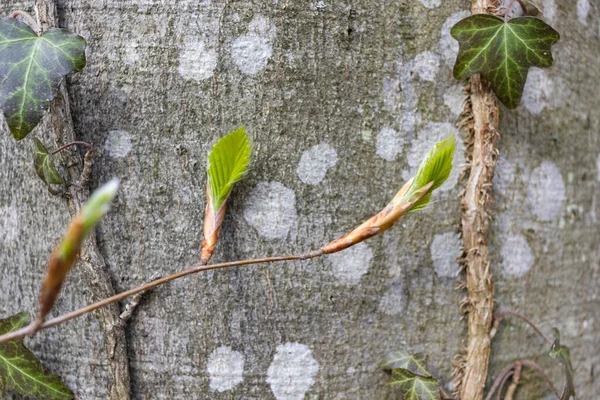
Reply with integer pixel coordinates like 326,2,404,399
0,312,73,400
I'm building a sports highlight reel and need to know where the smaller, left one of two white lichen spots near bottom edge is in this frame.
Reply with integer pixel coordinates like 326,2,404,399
207,346,244,392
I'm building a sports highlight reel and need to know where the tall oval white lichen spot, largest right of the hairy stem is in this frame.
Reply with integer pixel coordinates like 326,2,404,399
527,161,565,221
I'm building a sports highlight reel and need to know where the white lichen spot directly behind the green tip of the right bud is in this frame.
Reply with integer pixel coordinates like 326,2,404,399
402,122,465,192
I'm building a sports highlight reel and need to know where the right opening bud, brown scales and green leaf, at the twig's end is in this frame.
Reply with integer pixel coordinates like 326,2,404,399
321,135,454,254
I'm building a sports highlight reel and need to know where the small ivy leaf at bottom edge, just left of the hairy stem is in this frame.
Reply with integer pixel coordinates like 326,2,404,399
382,350,441,400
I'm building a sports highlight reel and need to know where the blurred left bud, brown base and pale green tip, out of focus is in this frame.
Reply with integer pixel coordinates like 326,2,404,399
37,179,119,323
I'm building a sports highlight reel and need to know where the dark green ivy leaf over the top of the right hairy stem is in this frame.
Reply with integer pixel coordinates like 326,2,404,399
451,14,560,109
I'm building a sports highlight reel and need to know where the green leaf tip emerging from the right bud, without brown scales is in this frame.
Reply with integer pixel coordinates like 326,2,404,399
400,134,456,212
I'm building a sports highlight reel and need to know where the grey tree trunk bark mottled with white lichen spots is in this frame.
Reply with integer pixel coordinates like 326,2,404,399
0,0,600,400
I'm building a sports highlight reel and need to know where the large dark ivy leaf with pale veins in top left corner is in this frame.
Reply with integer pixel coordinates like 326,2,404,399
0,18,86,140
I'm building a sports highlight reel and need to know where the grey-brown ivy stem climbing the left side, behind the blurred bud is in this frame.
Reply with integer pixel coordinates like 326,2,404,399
35,0,130,400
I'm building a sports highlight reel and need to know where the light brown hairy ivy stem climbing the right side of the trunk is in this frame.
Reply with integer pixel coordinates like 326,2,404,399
455,0,499,400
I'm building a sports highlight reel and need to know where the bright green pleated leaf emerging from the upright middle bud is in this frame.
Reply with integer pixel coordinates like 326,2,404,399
208,127,252,214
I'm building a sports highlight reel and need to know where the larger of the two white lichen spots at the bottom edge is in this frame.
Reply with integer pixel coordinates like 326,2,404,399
267,343,319,400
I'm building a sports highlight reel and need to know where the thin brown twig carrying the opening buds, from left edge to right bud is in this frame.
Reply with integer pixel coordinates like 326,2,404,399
0,250,323,343
